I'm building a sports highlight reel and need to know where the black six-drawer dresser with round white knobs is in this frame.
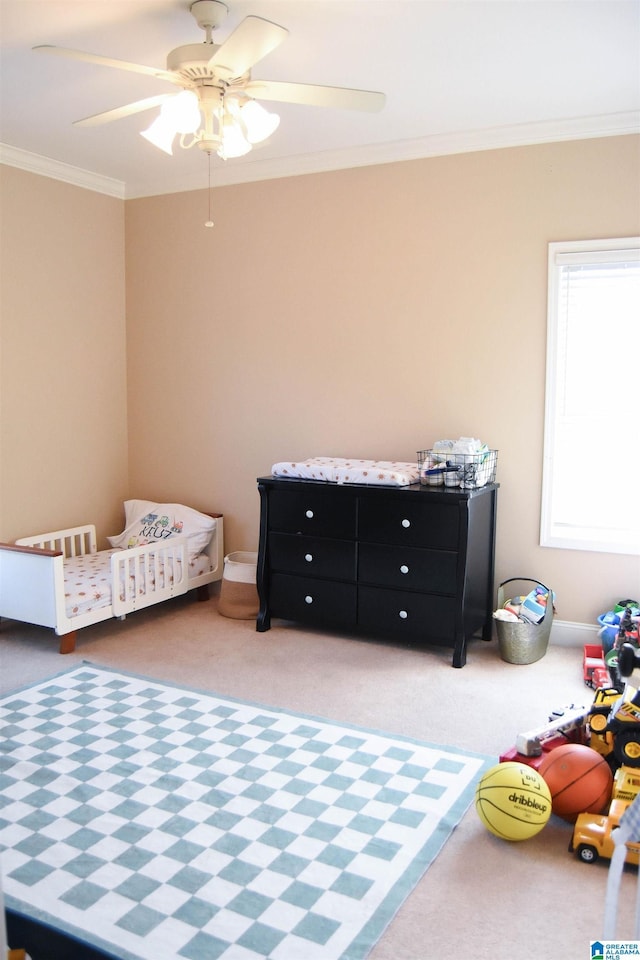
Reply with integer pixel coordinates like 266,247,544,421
257,477,498,667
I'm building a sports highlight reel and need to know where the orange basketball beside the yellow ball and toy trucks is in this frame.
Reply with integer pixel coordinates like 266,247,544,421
538,743,613,823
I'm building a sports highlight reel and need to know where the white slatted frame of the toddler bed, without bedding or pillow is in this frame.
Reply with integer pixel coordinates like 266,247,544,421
0,514,224,653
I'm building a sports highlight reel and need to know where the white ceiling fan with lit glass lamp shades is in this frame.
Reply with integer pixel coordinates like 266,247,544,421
33,0,385,159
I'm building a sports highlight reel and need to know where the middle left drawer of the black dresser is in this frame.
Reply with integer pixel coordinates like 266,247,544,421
269,533,356,581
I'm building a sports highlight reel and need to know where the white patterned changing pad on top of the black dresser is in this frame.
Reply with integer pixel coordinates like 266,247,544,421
271,457,420,487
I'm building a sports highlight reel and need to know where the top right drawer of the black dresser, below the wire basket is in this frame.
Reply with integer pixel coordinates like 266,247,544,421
358,496,460,550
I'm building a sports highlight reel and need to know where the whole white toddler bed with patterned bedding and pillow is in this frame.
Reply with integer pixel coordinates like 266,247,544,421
0,500,224,653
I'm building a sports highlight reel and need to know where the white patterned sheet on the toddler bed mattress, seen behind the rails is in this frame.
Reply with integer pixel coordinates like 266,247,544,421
64,550,212,617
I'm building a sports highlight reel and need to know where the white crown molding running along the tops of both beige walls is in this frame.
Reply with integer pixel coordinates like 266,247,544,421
0,111,640,199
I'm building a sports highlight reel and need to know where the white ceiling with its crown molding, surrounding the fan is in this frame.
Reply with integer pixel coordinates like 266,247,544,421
0,0,640,197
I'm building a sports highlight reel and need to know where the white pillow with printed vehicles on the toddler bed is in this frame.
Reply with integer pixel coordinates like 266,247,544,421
107,500,216,557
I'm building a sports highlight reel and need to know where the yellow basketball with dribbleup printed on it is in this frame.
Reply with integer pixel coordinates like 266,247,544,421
476,762,551,840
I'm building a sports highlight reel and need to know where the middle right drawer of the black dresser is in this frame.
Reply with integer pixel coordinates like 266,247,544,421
358,543,458,595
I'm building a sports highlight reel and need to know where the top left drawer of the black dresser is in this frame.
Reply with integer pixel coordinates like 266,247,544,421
269,488,356,540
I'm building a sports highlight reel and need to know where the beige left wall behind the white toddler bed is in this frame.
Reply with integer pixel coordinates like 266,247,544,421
0,166,127,541
